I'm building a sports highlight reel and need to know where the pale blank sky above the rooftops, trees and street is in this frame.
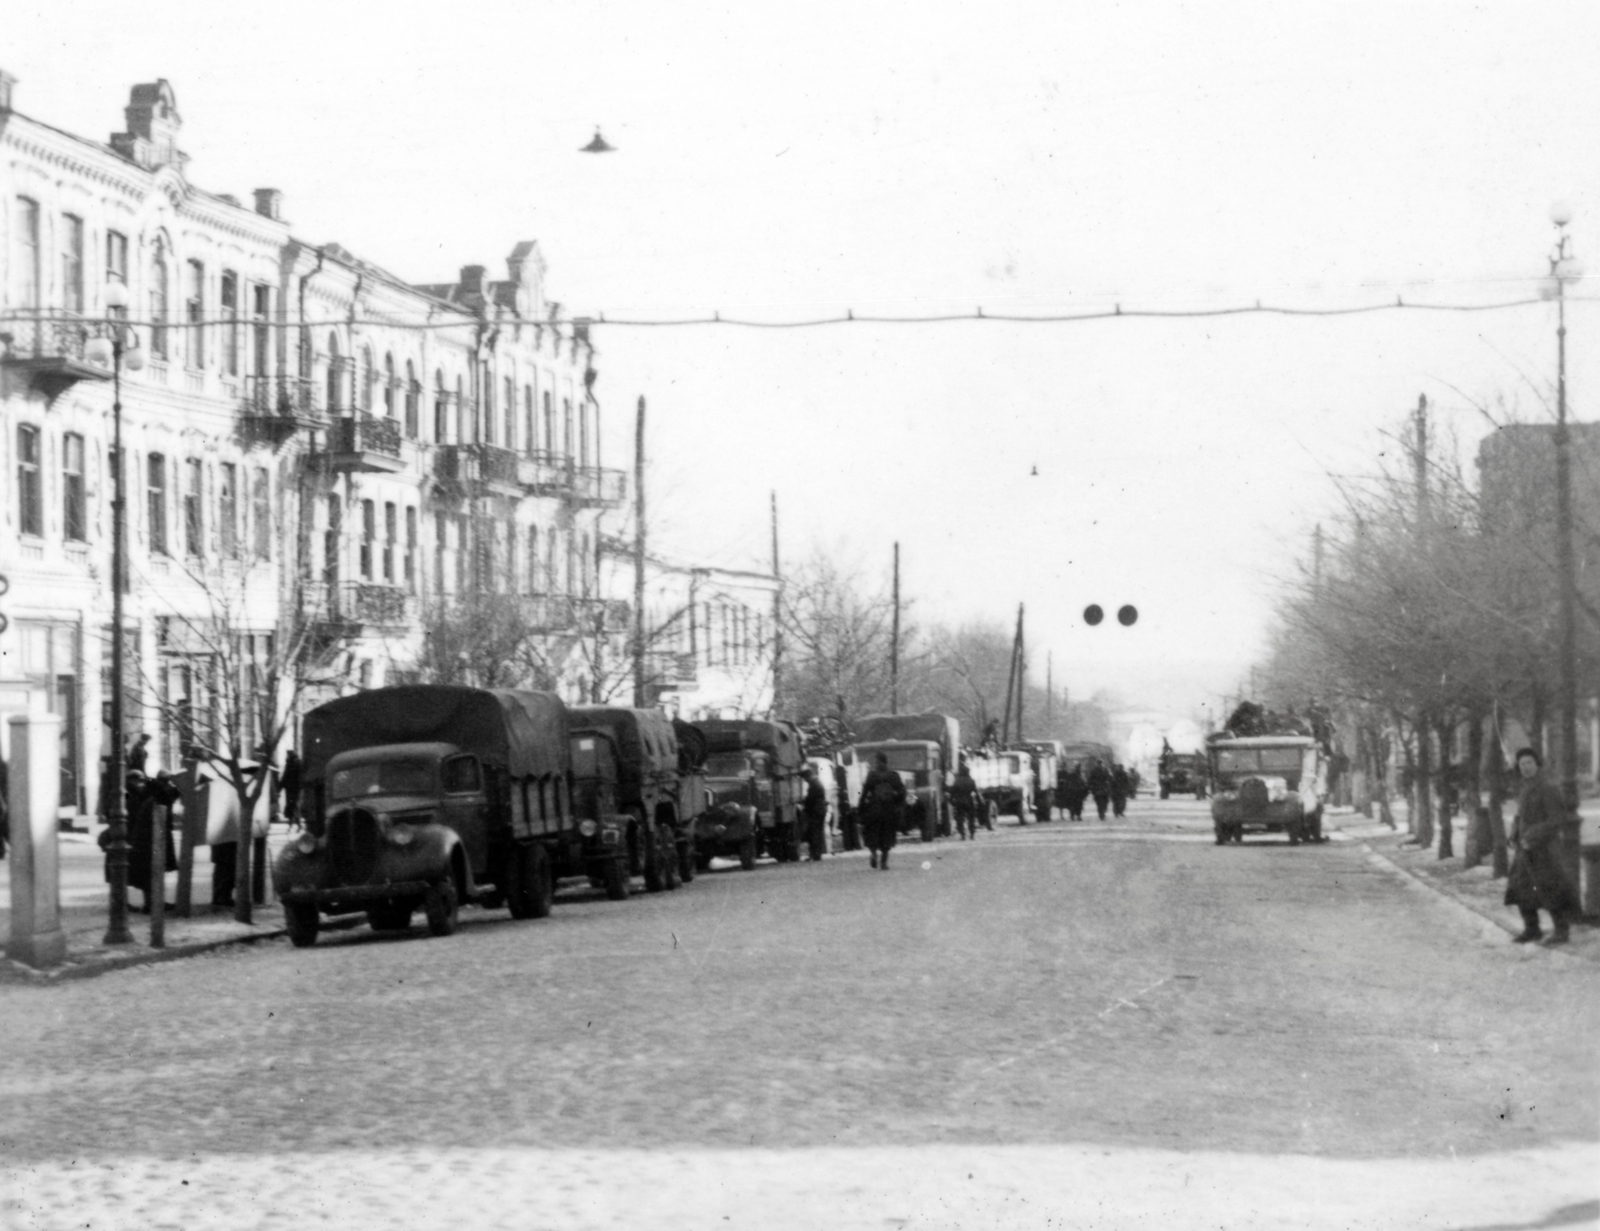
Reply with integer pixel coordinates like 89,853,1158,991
15,0,1600,720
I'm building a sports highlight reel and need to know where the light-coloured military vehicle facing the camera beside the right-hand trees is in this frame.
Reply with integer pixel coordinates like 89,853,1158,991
1206,735,1328,845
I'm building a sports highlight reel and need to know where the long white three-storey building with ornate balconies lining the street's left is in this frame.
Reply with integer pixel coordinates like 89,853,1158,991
0,74,626,813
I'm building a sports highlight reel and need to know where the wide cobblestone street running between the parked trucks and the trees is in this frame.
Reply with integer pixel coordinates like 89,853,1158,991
0,800,1600,1228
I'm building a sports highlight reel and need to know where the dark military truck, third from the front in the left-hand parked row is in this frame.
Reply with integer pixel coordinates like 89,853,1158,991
694,719,805,871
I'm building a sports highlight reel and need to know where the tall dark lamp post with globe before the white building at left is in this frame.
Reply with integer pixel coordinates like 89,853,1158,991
85,282,144,944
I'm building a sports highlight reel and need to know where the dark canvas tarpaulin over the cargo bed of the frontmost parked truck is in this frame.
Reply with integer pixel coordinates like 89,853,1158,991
302,684,570,781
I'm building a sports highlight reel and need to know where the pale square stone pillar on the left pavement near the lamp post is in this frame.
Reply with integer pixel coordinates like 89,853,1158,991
6,714,67,967
